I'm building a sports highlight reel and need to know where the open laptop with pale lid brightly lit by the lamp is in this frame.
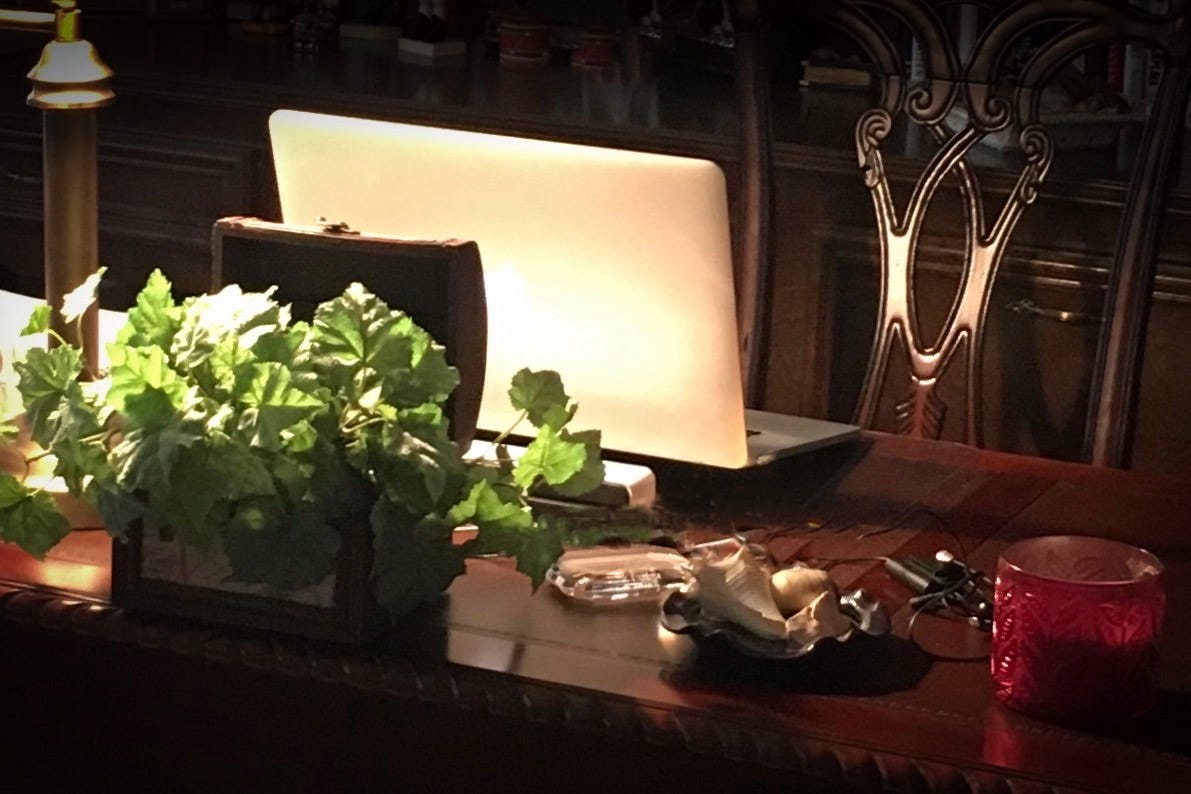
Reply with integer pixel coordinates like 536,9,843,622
269,110,858,469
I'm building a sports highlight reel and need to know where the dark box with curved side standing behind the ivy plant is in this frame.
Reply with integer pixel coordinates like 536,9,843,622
211,217,488,449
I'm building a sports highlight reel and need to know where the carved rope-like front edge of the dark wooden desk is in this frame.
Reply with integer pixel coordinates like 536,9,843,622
0,582,1086,794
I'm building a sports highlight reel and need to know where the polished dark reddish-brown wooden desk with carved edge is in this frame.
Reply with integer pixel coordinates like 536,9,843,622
0,433,1191,794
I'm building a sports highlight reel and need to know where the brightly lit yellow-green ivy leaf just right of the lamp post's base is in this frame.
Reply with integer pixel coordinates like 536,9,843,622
107,345,187,427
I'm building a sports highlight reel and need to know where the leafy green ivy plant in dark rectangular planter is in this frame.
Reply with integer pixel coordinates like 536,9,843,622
0,271,604,638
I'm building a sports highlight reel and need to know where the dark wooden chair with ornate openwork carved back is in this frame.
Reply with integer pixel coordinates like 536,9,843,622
736,0,1191,467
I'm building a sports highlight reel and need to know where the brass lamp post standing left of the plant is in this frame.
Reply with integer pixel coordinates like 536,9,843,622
0,0,116,373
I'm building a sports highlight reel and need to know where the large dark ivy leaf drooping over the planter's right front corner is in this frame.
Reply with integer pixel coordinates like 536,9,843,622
372,499,464,617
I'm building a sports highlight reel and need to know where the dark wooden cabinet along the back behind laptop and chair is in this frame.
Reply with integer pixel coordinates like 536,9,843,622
0,15,1191,473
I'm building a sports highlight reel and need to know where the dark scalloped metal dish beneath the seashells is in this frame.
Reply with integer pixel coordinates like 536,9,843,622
660,590,890,659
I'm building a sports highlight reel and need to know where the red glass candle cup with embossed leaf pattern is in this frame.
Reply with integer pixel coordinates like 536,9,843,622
992,534,1166,726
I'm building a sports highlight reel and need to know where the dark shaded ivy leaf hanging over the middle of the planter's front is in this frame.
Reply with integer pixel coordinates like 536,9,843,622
222,504,341,593
